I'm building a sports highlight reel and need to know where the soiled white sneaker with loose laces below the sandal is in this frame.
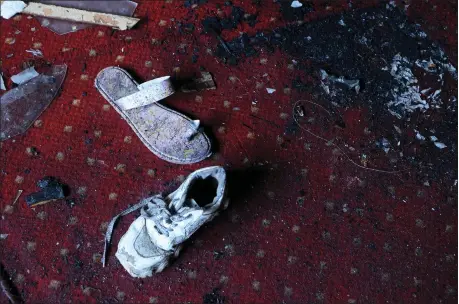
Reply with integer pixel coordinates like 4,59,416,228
103,167,228,278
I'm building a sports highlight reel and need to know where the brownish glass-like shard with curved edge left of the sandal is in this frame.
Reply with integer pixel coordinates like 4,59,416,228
0,65,67,141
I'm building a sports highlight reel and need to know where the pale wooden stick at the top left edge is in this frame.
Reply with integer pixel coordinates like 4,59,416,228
22,2,140,30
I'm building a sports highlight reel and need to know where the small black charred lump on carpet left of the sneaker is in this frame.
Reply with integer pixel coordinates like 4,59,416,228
25,177,66,207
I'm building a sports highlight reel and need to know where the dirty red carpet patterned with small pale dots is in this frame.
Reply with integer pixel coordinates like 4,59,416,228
0,0,457,304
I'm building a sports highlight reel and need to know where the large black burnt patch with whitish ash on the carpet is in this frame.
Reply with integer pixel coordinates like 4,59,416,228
215,1,457,126
